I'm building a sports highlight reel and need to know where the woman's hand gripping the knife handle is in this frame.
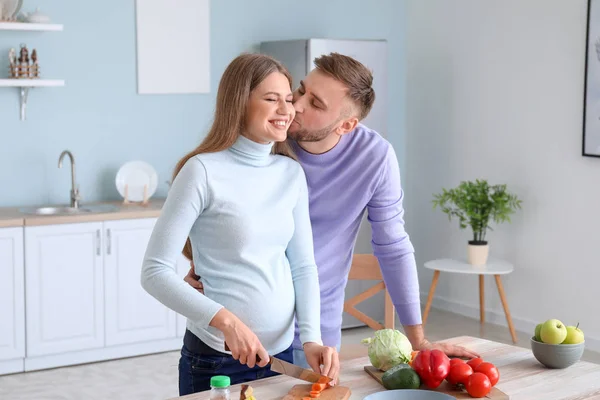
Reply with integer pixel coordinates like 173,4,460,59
210,308,269,368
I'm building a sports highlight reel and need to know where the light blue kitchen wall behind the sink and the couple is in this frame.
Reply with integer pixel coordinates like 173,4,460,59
0,0,405,206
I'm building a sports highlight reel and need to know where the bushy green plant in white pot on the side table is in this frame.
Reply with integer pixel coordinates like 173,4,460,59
433,179,521,266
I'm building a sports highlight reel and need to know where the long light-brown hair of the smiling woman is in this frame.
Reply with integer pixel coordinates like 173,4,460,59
173,53,296,260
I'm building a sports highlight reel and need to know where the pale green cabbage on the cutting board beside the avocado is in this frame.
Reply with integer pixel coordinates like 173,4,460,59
361,329,412,371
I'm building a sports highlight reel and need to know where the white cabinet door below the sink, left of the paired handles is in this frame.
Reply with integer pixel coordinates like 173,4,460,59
25,222,104,357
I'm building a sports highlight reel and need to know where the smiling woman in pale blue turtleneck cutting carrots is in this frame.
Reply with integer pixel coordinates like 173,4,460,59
141,54,339,395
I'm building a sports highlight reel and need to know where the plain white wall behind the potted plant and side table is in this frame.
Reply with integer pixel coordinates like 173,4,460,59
404,0,600,350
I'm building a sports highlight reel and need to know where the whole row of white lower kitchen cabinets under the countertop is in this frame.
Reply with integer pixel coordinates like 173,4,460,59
0,212,189,375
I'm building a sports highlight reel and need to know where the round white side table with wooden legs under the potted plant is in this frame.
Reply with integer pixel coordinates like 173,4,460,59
423,257,517,343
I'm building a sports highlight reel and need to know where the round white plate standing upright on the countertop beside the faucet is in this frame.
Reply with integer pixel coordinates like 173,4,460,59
115,161,158,201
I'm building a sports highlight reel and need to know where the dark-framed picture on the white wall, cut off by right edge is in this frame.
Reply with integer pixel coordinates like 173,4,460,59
582,0,600,157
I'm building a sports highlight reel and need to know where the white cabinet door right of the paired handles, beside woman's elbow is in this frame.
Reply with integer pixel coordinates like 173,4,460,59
103,218,177,346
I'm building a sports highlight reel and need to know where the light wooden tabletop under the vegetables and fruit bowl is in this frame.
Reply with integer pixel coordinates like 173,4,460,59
168,336,600,400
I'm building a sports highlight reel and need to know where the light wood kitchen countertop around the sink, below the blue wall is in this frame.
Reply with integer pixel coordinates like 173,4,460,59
0,199,165,228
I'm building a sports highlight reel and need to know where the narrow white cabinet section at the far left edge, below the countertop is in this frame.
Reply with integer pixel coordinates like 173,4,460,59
0,227,25,374
